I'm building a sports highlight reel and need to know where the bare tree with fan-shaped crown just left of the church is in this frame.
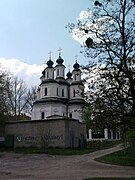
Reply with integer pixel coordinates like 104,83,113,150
7,77,36,120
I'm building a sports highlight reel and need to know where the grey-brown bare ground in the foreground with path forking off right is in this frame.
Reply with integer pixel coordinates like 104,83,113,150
0,145,135,180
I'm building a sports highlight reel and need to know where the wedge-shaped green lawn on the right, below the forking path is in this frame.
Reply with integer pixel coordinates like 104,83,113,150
96,148,135,166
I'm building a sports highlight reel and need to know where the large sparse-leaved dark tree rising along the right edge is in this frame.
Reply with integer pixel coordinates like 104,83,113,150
67,0,135,131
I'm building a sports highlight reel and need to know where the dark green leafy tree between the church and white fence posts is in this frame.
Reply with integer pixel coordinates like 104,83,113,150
82,97,120,134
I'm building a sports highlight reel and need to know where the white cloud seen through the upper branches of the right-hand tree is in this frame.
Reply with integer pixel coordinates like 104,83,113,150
72,11,114,45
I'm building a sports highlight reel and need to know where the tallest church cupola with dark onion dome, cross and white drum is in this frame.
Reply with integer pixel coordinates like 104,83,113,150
55,49,65,78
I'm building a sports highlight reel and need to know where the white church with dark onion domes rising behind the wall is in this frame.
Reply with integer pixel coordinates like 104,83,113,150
31,53,86,122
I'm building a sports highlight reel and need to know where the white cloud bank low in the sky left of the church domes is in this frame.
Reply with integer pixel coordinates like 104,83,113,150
0,58,44,87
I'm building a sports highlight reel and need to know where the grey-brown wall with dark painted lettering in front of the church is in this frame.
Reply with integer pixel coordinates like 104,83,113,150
5,118,86,148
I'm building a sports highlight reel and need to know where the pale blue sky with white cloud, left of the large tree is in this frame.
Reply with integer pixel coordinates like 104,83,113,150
0,0,90,85
